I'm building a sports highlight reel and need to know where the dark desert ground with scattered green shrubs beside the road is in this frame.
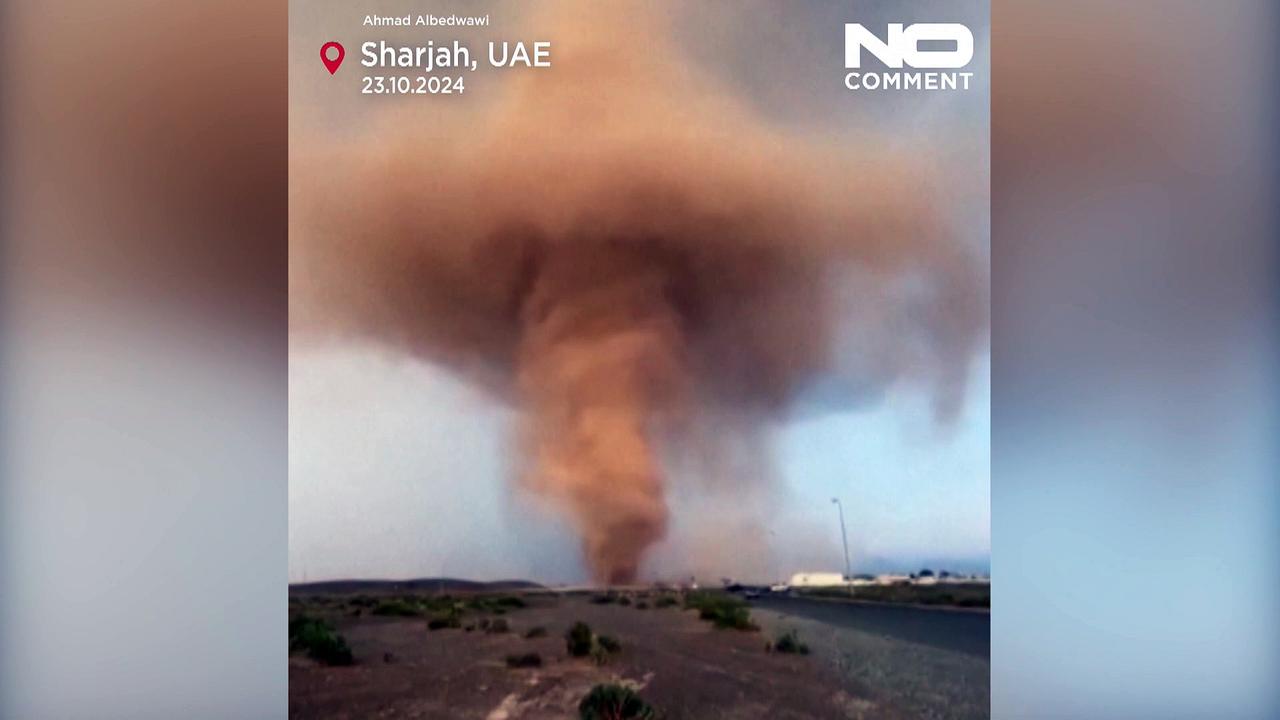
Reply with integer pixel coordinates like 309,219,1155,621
289,589,989,720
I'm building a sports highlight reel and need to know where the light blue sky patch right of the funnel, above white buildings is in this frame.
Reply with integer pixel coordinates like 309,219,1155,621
777,359,991,571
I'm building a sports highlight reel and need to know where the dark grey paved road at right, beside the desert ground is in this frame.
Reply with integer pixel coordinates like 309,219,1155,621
750,596,991,661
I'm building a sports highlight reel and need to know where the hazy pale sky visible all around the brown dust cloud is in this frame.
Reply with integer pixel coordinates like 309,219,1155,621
289,1,991,582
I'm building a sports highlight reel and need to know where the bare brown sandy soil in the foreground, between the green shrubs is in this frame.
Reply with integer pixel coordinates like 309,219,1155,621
289,596,989,720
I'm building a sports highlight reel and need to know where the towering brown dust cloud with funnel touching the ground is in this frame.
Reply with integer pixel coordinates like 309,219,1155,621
289,4,988,583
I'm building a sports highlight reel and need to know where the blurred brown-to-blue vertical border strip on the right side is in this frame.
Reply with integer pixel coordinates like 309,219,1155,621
992,0,1280,719
